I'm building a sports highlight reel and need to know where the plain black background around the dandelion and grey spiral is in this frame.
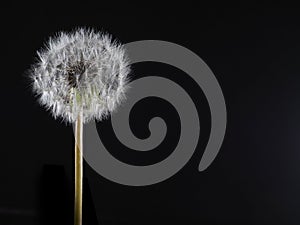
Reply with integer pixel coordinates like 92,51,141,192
0,2,300,225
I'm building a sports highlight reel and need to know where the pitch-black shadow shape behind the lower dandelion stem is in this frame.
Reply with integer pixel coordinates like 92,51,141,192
39,165,98,225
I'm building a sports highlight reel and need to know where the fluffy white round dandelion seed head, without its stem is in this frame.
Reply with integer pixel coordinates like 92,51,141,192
30,28,130,123
